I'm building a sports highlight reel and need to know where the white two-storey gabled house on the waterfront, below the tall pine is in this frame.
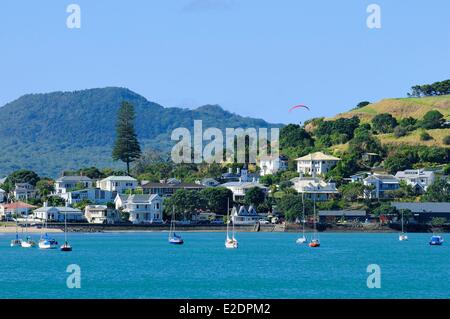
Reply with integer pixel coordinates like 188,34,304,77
115,194,163,224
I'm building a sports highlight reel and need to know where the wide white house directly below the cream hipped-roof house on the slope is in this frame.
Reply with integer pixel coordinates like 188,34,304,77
291,177,338,201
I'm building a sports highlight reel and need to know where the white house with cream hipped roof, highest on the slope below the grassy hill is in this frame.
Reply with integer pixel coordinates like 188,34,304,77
296,152,340,175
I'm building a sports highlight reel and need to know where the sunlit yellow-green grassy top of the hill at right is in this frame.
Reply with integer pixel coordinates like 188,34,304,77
335,95,450,122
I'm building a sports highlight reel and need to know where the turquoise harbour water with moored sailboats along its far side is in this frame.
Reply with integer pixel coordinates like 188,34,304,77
0,232,450,298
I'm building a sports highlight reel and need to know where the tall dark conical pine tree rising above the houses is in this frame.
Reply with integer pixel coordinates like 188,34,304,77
112,101,141,175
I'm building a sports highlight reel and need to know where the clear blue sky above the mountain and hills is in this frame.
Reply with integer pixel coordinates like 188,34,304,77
0,0,450,123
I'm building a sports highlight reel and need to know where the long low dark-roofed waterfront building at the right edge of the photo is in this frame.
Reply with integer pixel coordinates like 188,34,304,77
391,202,450,224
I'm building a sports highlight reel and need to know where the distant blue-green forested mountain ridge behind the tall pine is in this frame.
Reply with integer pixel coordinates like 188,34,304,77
0,87,281,177
